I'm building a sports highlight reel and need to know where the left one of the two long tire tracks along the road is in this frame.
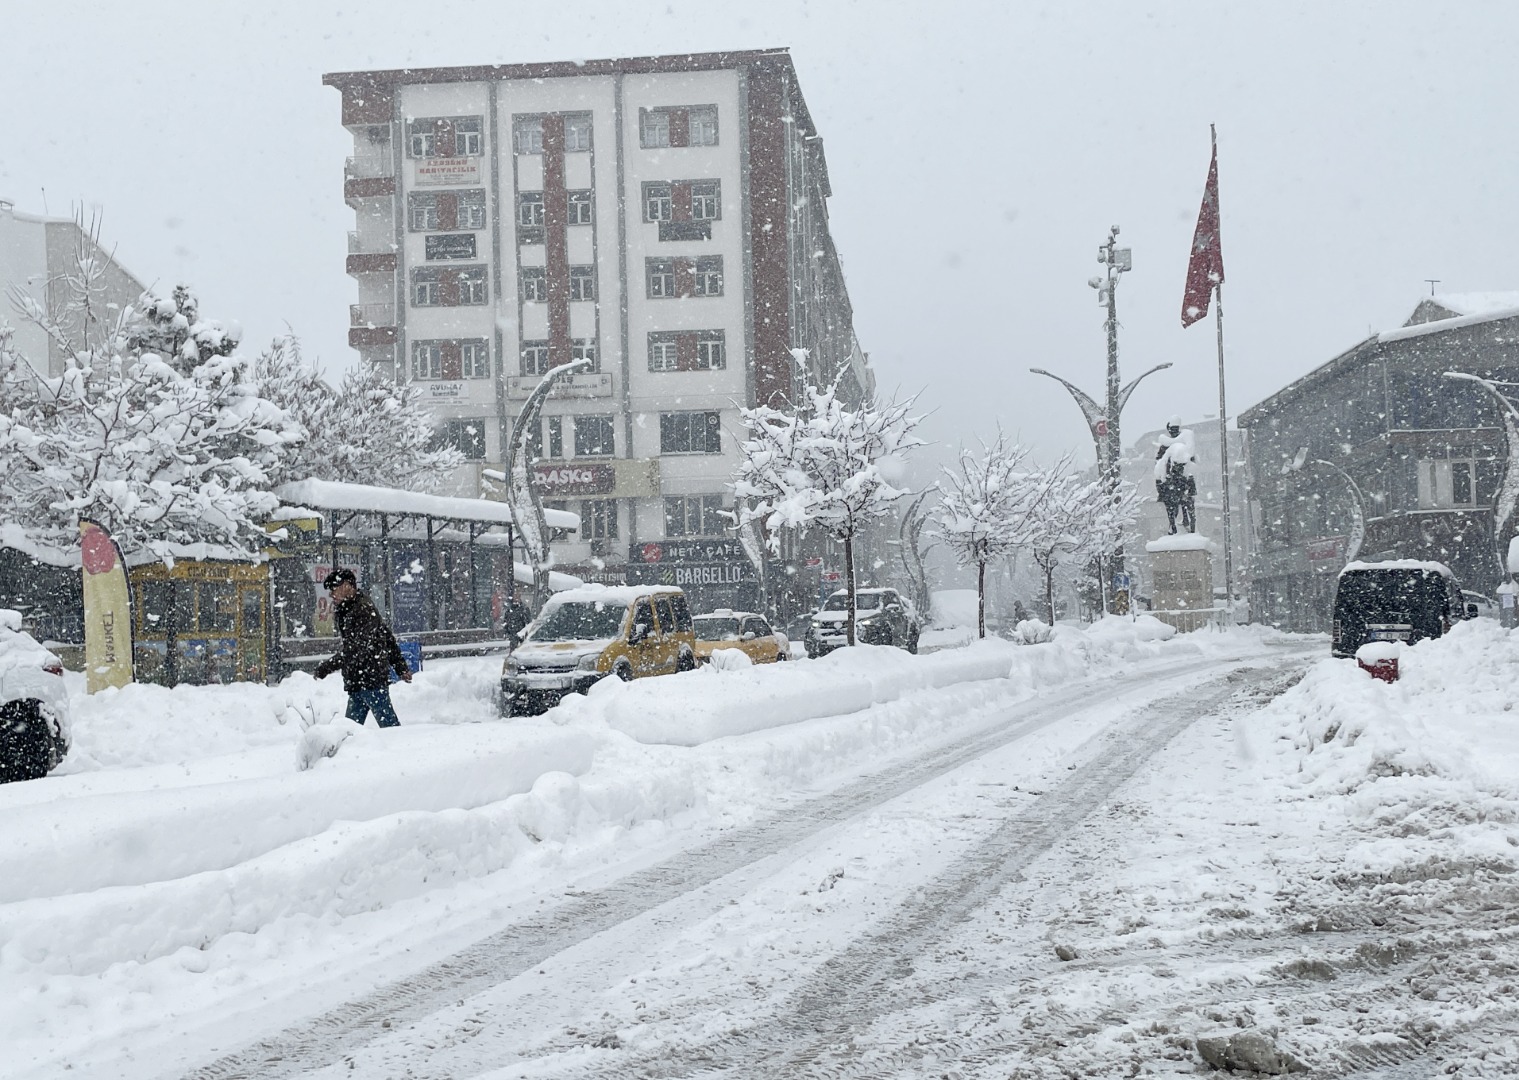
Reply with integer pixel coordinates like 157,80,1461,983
166,658,1261,1080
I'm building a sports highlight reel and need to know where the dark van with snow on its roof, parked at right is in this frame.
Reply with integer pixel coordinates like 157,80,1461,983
1334,559,1466,656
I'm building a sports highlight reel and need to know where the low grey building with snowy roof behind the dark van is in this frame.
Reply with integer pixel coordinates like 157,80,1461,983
1240,293,1519,632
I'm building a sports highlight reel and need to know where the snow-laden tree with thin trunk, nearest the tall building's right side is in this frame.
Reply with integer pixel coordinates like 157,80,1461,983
734,367,921,646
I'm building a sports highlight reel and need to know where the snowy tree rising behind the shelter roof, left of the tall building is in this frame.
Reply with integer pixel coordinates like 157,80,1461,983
254,334,463,491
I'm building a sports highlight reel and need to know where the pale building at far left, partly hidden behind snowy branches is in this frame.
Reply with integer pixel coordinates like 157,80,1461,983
0,199,144,375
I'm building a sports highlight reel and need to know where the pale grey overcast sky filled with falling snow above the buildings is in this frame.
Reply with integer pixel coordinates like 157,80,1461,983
0,0,1519,470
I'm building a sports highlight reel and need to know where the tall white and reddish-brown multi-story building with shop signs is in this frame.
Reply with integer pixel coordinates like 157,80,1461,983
324,50,873,616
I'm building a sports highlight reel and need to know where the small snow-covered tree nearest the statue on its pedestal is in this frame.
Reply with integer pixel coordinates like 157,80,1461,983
1027,473,1139,626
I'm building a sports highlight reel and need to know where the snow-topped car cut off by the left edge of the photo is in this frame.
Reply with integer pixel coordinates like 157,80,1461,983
0,608,68,782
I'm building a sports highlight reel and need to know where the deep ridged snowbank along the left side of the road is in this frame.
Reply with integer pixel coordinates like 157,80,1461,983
0,618,1282,1074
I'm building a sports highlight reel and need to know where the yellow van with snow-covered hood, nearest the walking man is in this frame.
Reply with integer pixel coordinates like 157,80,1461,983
501,585,696,717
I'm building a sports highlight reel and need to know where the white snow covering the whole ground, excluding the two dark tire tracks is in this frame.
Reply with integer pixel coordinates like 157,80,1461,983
0,620,1519,1080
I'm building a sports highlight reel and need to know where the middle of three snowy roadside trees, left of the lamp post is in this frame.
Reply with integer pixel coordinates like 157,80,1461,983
936,434,1063,638
